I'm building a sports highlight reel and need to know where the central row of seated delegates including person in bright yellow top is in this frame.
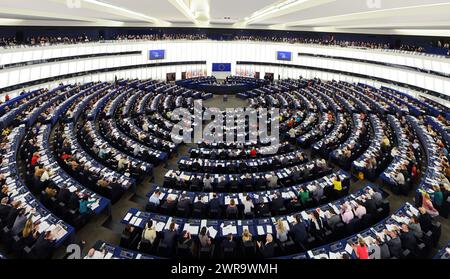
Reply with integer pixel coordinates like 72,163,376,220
146,173,349,219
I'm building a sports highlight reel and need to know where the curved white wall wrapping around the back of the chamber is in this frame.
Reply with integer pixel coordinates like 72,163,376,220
0,41,450,99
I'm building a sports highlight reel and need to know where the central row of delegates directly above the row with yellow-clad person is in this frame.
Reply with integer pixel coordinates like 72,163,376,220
164,159,331,192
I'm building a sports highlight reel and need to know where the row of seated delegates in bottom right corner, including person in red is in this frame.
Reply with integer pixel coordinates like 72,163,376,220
285,203,441,259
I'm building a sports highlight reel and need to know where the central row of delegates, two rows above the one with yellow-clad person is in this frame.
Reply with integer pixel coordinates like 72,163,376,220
178,151,308,173
